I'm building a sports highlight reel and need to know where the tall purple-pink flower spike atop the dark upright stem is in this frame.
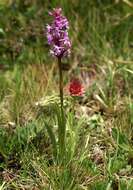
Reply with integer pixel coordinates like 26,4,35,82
46,8,71,58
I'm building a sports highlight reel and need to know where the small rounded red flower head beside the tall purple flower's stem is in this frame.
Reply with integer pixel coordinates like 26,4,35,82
69,79,84,96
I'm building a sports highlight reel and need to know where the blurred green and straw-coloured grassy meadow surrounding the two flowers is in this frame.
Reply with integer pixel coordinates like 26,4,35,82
0,0,133,190
